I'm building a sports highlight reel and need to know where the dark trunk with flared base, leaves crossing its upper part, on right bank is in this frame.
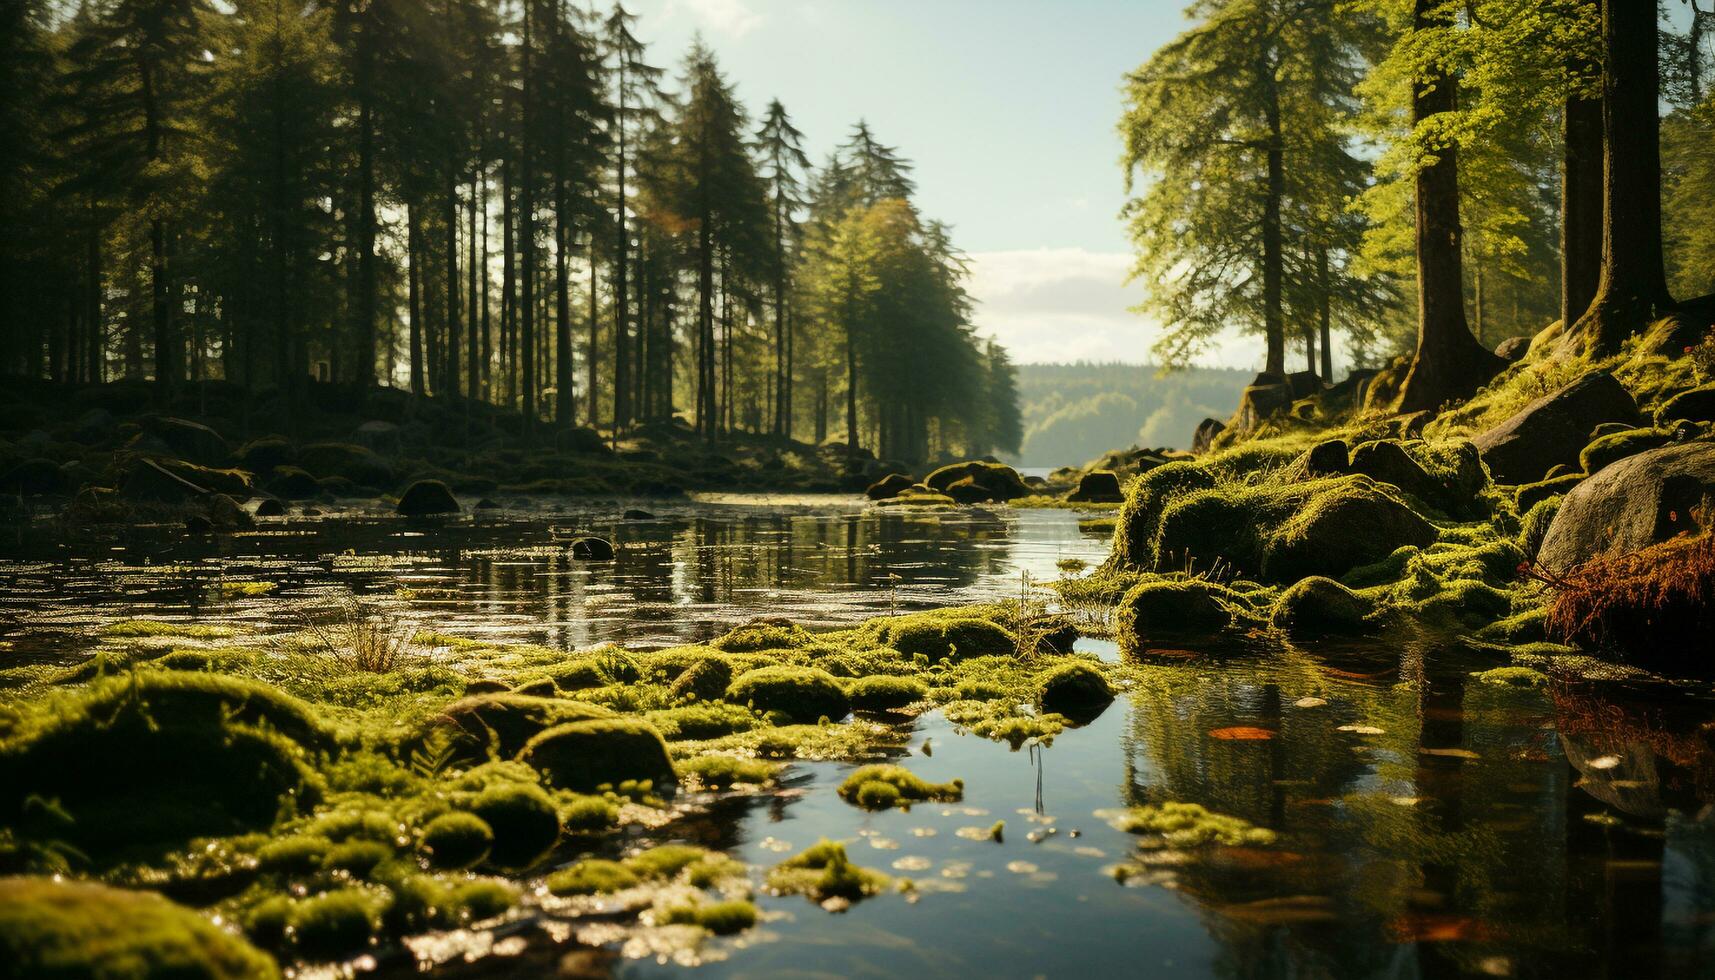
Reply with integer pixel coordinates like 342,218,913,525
1399,0,1506,412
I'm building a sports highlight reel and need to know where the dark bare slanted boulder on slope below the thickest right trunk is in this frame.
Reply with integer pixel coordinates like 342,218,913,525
1475,371,1643,484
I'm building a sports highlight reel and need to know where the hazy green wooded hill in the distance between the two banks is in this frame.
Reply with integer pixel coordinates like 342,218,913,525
1008,362,1255,467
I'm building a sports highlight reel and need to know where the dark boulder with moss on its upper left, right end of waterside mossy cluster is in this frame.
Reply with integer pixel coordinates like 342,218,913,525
1262,475,1435,582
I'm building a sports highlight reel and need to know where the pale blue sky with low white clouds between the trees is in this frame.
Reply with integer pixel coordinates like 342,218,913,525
626,0,1207,367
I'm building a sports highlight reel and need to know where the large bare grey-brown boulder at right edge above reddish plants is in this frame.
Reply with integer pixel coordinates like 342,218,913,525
1537,443,1715,573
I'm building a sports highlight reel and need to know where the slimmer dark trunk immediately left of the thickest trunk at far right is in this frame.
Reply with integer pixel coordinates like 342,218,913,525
1561,7,1602,328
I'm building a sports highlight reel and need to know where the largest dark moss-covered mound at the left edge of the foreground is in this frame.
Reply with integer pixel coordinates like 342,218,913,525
0,671,336,856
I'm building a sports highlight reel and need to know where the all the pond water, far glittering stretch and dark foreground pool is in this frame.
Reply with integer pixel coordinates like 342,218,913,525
0,499,1715,977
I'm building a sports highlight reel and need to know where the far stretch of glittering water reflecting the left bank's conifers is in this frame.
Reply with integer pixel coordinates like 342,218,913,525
0,498,1108,662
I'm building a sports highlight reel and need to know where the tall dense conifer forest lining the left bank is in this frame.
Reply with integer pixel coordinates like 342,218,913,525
0,0,1017,460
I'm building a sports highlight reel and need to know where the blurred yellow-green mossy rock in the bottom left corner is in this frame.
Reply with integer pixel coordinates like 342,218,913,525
0,877,280,980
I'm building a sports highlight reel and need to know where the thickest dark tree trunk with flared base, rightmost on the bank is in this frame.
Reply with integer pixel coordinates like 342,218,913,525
1578,0,1674,355
